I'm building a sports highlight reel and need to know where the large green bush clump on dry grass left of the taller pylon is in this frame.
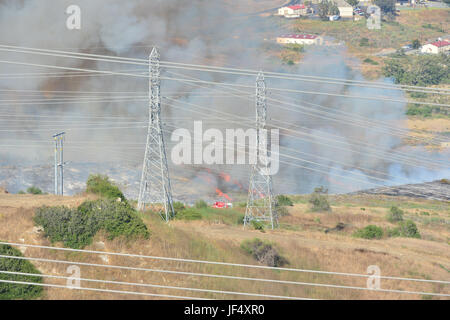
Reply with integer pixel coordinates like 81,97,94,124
34,200,150,249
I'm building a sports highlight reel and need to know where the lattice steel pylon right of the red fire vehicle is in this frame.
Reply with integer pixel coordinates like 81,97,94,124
244,72,278,229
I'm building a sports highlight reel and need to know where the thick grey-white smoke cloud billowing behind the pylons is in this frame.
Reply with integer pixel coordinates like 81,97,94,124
0,0,450,197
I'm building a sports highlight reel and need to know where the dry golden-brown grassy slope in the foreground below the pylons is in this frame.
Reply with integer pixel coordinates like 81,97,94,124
0,195,450,299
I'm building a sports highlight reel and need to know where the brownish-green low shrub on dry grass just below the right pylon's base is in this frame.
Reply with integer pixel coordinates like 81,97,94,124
241,238,289,267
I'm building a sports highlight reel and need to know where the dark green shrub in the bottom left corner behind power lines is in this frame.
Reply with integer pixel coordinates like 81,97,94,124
0,244,43,300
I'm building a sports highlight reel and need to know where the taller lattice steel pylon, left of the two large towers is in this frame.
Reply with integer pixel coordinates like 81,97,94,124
138,48,174,221
